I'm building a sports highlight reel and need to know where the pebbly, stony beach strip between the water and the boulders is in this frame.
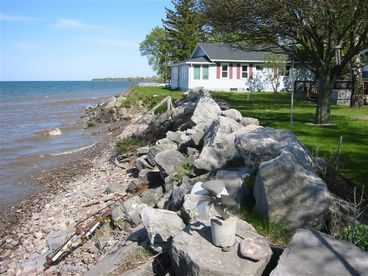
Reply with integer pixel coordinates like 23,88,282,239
0,118,137,275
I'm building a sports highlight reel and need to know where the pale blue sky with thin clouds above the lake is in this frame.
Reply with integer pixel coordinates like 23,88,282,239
0,0,172,81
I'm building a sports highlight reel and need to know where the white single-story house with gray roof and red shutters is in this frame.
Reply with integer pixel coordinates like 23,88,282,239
170,43,313,92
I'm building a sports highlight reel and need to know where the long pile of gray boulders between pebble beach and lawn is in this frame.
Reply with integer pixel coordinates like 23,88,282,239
85,89,366,275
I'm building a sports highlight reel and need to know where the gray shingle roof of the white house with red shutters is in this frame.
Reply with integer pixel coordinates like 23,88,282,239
198,43,264,61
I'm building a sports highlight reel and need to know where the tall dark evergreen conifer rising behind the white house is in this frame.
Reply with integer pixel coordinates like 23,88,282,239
162,0,204,62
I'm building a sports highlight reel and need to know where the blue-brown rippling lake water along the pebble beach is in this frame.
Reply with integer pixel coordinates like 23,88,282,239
0,81,135,210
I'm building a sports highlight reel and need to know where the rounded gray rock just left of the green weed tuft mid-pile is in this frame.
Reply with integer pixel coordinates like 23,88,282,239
155,150,185,176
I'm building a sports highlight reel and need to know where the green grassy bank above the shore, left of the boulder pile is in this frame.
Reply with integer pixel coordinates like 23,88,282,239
123,86,184,112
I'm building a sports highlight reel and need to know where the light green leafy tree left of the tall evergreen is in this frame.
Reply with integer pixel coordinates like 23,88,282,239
139,26,170,80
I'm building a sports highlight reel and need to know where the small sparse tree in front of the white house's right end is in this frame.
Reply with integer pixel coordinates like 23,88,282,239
264,53,287,92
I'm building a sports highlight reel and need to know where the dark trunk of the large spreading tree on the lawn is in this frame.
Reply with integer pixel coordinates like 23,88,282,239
315,70,335,124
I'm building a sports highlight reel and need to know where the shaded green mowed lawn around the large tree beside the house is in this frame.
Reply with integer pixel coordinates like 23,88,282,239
213,92,368,195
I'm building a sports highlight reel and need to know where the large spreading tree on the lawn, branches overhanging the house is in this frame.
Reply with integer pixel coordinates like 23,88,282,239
200,0,368,123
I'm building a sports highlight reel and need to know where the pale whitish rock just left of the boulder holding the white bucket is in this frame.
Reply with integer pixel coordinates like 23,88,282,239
140,206,185,252
